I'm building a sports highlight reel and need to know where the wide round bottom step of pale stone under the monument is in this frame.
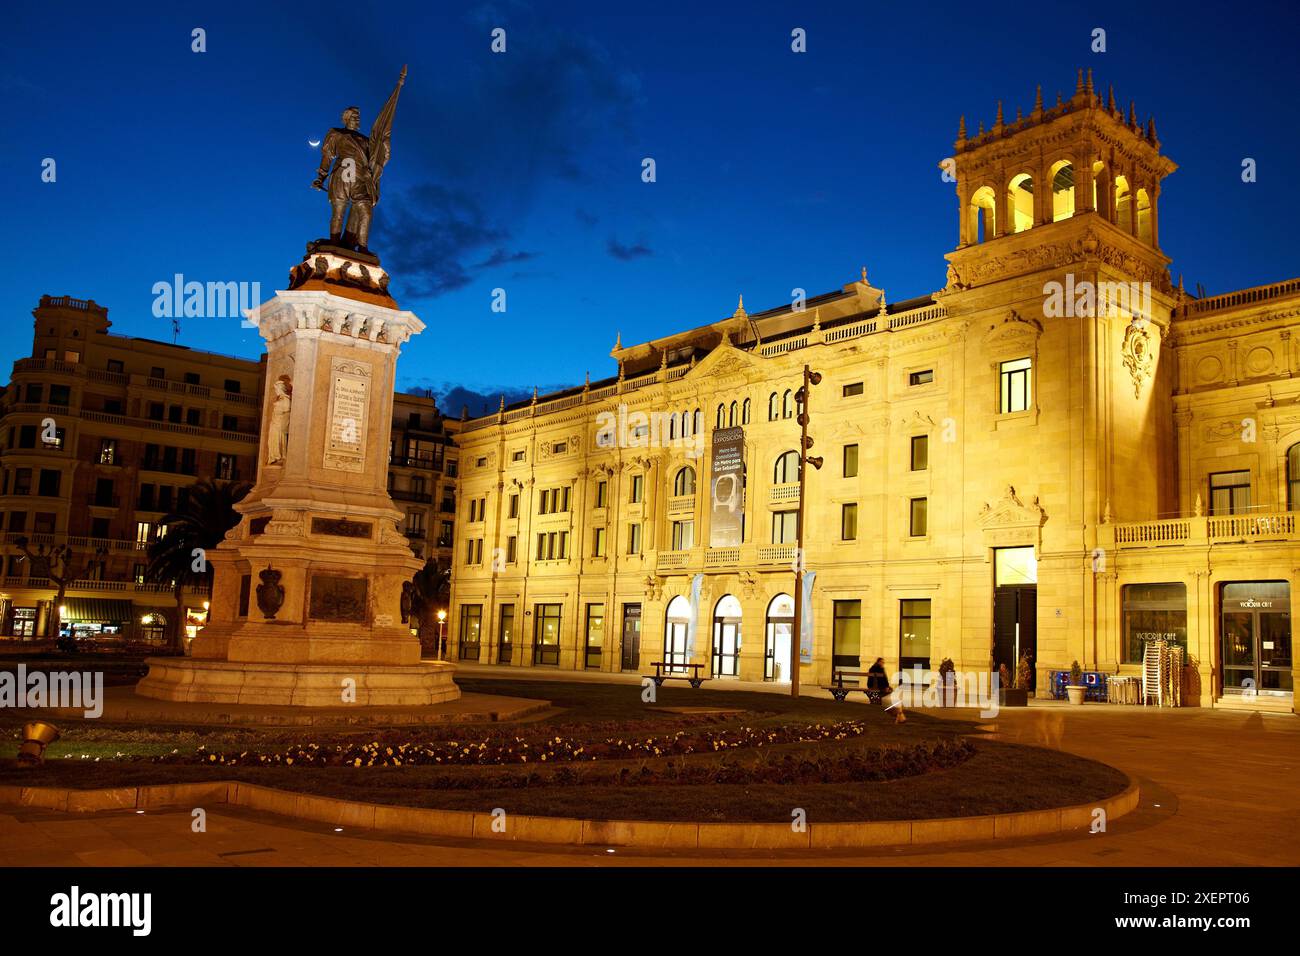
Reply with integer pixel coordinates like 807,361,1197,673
135,657,460,708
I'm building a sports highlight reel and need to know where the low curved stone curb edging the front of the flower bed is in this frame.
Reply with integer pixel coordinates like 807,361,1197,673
0,778,1140,849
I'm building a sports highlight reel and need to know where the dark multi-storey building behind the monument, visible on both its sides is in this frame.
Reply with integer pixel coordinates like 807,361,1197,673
0,295,459,641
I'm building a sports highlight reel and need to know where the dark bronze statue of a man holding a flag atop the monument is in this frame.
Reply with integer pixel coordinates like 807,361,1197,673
312,66,406,254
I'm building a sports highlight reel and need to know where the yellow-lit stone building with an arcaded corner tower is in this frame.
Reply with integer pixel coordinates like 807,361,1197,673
449,74,1300,710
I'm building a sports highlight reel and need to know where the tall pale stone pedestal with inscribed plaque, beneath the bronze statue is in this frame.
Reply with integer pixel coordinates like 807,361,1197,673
137,243,460,706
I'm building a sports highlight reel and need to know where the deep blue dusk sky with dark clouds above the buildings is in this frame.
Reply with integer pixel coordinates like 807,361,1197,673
10,0,1300,414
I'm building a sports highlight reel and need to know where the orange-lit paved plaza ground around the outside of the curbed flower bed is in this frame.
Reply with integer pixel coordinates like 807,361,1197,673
0,669,1300,866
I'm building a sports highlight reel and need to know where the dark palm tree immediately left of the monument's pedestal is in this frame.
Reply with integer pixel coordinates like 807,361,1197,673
144,477,252,654
